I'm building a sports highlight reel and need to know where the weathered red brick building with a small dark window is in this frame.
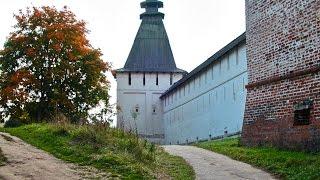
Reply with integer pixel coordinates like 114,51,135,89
242,0,320,151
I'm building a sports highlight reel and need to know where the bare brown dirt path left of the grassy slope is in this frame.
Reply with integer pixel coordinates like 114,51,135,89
0,132,110,180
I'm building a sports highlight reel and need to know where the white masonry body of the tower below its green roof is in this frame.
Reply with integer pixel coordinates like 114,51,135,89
116,73,183,144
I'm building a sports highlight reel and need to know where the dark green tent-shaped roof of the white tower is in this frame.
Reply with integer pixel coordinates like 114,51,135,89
117,0,186,73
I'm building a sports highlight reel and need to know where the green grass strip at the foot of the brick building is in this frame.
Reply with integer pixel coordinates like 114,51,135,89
195,138,320,180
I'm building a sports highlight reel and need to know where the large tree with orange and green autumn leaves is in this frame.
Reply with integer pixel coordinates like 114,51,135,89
0,7,110,122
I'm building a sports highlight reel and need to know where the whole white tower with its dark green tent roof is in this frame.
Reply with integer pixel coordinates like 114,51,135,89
115,0,186,144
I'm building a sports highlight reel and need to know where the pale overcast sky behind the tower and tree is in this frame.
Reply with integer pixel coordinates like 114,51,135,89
0,0,245,121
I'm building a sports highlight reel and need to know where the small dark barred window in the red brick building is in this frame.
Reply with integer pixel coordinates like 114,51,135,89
294,100,313,126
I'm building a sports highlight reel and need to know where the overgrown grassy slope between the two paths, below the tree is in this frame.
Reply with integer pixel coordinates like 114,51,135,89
0,124,194,179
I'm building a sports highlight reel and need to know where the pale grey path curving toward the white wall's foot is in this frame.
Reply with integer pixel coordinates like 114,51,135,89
164,146,274,180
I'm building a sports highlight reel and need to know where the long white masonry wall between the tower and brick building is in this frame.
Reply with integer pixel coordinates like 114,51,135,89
162,43,248,144
